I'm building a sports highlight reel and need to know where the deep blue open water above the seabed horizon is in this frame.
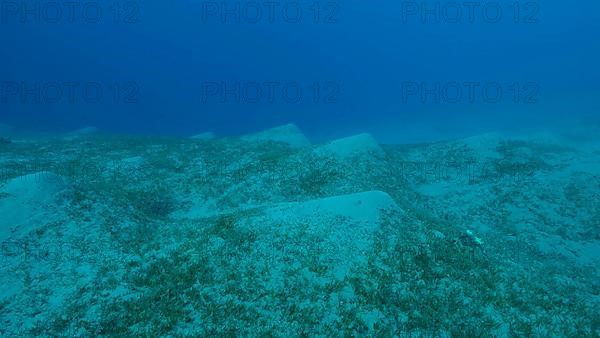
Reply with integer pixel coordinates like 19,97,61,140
0,0,600,141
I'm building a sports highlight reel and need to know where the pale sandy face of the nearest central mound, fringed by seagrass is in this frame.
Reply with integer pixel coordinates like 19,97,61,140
233,191,400,280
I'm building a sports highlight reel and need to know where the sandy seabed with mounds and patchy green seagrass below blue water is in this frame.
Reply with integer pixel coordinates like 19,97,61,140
0,126,600,337
